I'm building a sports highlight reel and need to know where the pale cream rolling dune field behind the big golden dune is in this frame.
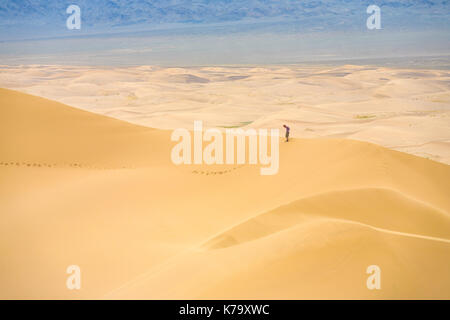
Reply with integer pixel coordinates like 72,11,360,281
0,65,450,164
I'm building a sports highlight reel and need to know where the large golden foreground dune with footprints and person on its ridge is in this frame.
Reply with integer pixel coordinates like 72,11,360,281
0,88,450,299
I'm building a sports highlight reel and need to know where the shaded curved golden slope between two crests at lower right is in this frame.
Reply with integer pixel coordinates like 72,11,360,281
203,188,450,249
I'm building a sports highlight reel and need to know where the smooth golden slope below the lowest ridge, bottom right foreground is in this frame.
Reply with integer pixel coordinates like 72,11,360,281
106,218,450,299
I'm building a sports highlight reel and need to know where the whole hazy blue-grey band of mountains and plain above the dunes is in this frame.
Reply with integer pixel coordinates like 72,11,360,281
0,0,450,67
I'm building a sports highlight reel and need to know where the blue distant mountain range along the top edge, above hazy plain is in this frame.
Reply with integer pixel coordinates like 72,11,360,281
0,0,450,39
